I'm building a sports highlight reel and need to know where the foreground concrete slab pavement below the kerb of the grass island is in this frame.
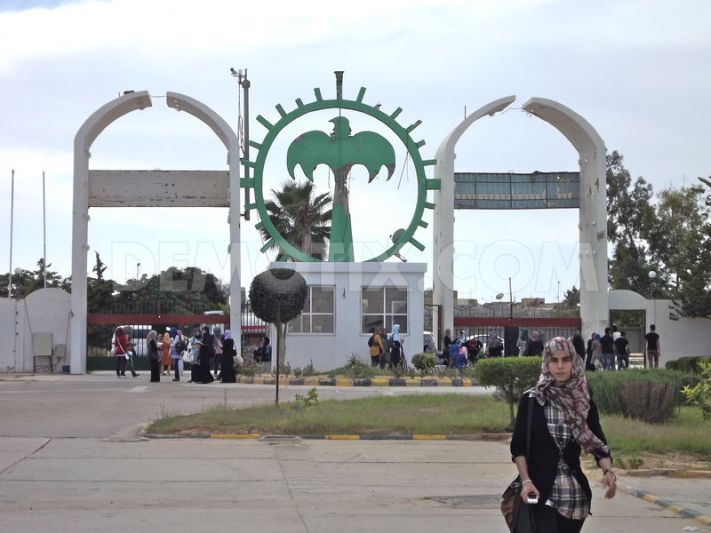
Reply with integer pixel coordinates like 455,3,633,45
0,438,705,533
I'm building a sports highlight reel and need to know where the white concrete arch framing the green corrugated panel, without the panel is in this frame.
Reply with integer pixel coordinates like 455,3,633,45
433,96,609,340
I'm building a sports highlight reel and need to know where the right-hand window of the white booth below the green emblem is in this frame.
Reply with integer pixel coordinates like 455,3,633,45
361,287,407,333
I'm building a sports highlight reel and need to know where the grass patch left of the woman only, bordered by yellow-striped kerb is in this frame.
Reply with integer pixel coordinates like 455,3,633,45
146,394,508,435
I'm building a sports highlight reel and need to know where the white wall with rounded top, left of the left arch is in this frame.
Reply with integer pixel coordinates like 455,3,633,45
0,289,71,373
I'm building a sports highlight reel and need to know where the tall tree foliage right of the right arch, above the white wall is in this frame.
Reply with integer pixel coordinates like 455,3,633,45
607,151,711,318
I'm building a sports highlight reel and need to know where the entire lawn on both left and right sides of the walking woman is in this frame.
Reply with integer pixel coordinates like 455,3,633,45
147,394,711,463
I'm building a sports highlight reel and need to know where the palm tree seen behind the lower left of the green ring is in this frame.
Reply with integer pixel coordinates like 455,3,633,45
260,182,332,261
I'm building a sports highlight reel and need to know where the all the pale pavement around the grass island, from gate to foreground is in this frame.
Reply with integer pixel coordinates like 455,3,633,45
0,375,711,533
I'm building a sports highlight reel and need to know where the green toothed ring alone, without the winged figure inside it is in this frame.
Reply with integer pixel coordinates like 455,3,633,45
241,87,440,262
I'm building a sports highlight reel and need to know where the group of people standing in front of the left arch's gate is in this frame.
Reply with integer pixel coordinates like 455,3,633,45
112,326,237,383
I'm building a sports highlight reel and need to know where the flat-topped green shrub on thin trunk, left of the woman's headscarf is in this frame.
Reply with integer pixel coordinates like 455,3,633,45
474,357,543,427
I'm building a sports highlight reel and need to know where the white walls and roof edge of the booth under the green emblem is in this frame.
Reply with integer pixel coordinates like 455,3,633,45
270,263,427,370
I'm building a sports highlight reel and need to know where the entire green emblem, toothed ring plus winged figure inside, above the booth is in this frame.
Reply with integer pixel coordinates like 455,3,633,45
240,72,440,262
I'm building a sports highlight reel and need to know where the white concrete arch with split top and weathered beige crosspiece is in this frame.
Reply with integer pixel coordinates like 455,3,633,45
70,91,241,373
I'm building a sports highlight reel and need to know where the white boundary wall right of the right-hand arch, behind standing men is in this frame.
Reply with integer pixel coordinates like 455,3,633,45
609,290,711,367
